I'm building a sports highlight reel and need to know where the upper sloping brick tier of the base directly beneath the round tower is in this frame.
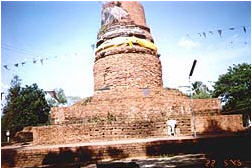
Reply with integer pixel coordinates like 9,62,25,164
51,88,220,124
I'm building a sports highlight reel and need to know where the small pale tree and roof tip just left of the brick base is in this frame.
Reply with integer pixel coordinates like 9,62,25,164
47,88,67,107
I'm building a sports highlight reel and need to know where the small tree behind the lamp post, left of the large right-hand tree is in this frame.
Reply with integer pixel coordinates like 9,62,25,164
192,81,211,99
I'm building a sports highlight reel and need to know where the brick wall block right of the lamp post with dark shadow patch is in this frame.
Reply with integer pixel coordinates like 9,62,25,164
195,114,244,133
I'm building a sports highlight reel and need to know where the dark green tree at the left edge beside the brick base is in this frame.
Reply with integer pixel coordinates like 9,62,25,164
1,76,50,135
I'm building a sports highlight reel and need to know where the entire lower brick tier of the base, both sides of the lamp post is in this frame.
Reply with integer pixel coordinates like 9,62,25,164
33,110,244,144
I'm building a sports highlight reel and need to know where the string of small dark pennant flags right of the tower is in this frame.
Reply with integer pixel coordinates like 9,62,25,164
186,26,248,38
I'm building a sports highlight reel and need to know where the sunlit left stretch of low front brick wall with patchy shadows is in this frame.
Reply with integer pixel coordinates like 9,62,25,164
1,142,156,168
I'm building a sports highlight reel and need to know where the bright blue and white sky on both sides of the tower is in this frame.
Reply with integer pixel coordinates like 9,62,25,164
1,1,251,97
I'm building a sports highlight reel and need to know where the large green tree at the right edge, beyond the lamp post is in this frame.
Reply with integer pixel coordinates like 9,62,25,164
213,63,251,122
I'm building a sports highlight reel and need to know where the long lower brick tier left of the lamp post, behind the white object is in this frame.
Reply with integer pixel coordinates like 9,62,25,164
33,116,191,144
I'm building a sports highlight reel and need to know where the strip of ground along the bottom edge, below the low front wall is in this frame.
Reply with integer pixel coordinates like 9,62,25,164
82,154,251,168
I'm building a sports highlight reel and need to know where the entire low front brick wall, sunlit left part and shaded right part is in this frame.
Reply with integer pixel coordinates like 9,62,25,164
1,136,251,168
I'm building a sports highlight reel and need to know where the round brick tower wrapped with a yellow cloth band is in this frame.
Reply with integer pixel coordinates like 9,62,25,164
94,1,162,91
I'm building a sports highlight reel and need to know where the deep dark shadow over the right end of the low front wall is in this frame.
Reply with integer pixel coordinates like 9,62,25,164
146,133,251,167
